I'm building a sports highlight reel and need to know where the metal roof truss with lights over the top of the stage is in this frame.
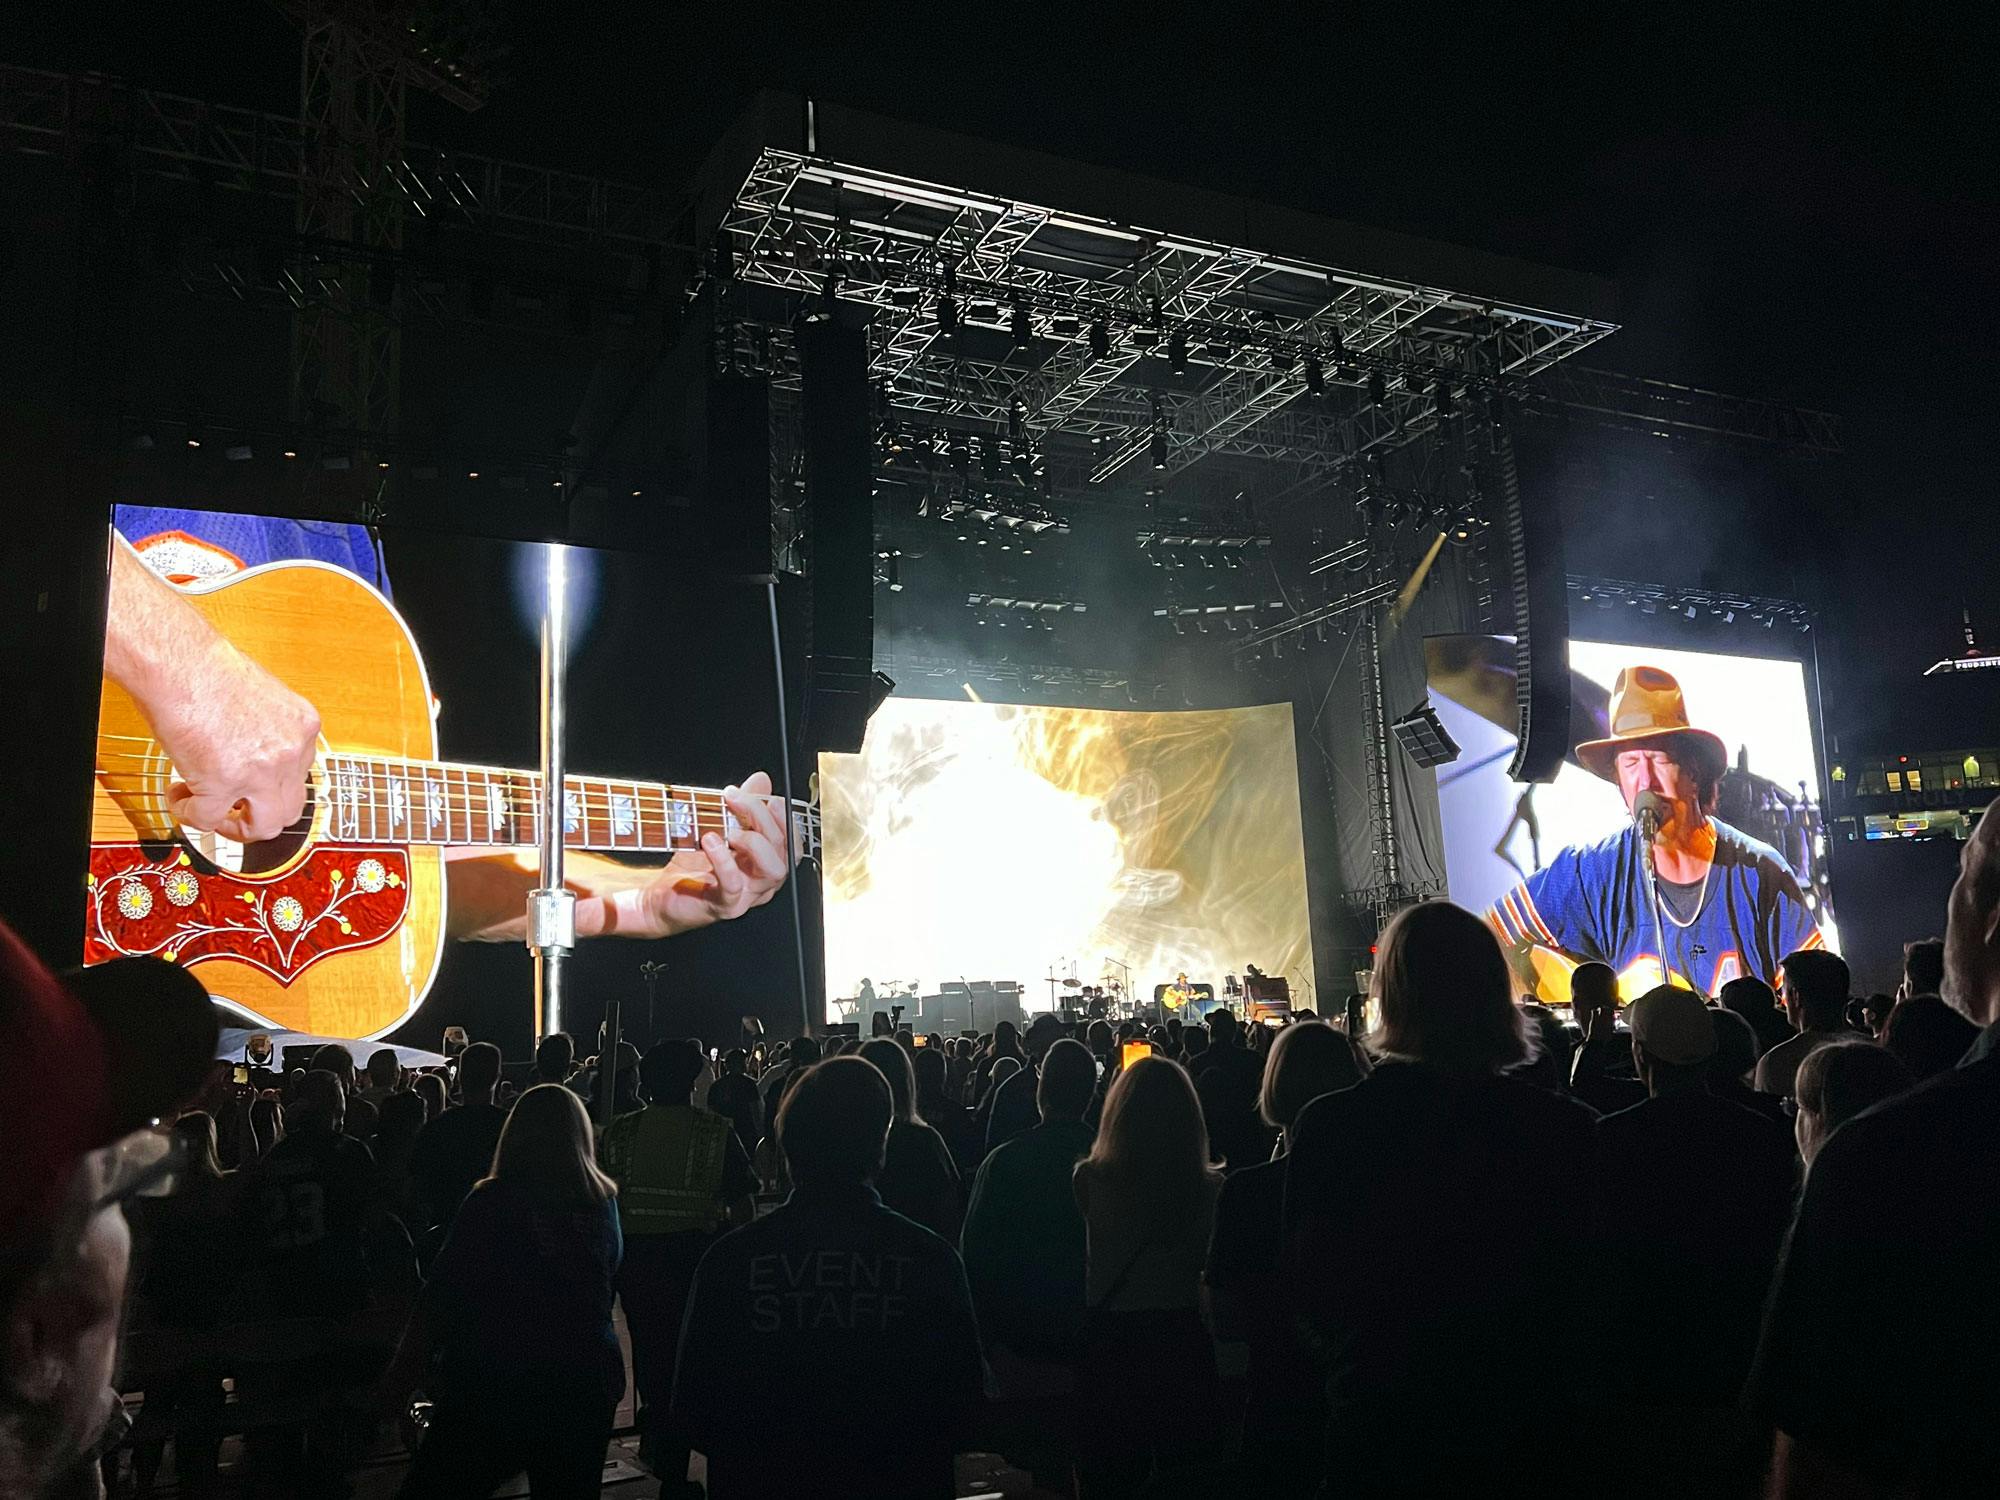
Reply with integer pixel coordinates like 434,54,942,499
714,148,1614,484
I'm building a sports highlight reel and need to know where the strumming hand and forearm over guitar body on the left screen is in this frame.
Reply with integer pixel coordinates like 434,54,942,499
104,540,320,844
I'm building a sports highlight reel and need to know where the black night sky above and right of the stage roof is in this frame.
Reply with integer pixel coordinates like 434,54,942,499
31,0,2000,728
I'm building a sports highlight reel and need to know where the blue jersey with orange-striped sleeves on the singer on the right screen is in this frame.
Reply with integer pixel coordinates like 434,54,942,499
1486,818,1822,1000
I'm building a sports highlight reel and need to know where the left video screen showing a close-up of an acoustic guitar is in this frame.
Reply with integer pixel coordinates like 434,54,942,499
78,506,808,1052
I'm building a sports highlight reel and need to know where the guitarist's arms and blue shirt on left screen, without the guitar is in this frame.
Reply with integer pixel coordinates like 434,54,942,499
104,506,788,942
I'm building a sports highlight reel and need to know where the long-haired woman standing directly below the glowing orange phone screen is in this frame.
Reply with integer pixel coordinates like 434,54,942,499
1074,1064,1222,1500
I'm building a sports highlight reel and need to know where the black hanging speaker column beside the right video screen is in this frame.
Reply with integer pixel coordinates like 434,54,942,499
1496,426,1570,782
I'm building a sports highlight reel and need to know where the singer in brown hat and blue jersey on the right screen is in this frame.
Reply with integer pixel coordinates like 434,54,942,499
1486,666,1822,1004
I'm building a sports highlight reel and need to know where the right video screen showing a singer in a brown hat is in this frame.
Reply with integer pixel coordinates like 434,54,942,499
1426,636,1838,1004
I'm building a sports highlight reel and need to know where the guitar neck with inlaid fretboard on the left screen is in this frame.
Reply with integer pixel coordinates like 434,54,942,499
320,754,818,858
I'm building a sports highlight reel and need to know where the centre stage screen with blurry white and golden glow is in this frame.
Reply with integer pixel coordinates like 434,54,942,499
820,698,1312,1018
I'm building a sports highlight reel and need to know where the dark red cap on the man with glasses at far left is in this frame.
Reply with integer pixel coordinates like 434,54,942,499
0,922,216,1242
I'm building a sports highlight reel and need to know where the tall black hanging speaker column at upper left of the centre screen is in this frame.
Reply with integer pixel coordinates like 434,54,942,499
798,318,882,752
